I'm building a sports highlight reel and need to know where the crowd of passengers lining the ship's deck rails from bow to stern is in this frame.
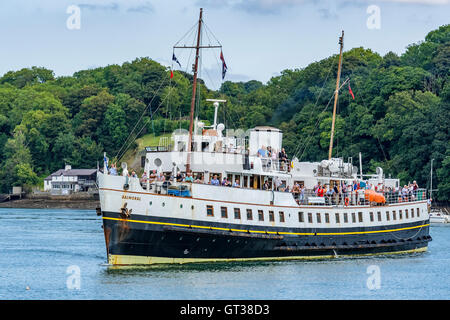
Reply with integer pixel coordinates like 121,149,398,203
108,162,425,204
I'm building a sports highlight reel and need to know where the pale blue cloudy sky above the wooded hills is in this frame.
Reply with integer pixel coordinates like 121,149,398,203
0,0,450,89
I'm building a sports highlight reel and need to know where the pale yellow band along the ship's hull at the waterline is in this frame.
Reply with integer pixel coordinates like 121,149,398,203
108,247,427,266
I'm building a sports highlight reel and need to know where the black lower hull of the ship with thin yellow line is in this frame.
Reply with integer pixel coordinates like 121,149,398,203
103,212,431,264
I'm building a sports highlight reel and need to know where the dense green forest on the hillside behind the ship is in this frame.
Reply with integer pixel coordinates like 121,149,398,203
0,25,450,201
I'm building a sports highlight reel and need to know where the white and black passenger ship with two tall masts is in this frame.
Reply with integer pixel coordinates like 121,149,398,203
97,12,431,265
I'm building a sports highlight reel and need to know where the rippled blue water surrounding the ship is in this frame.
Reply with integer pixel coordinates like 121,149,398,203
0,208,450,300
